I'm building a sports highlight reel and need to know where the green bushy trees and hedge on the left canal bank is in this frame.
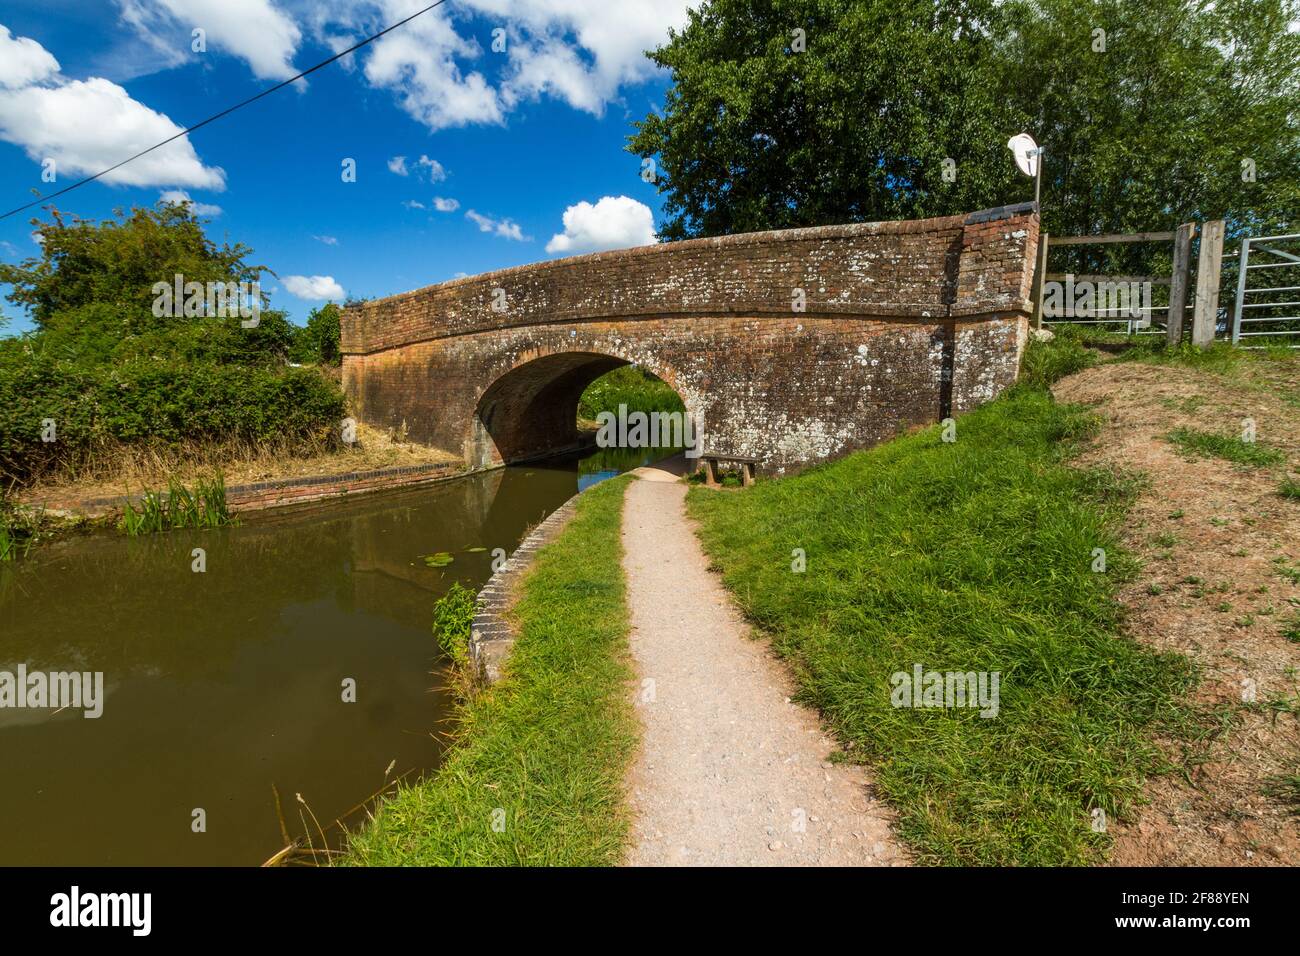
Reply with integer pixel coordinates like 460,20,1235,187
0,203,345,484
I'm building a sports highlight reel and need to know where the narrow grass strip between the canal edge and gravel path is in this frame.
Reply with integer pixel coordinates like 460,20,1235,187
343,477,637,866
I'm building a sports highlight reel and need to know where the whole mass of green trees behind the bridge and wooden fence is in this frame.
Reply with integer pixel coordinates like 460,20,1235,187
628,0,1300,247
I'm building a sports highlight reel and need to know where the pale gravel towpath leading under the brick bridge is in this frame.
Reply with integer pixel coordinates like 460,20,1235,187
623,457,905,866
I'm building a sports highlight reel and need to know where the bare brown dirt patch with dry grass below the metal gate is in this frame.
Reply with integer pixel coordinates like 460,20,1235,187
1053,362,1300,866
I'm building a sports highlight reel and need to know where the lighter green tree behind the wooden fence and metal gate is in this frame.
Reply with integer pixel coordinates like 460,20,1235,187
993,0,1300,251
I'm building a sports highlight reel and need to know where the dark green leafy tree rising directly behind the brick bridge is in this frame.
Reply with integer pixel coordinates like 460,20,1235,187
629,0,1014,239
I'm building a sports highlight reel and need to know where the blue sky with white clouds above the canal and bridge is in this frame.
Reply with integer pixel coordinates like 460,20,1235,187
0,0,685,334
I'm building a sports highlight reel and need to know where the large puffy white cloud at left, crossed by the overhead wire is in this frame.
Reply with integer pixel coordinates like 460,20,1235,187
0,77,225,190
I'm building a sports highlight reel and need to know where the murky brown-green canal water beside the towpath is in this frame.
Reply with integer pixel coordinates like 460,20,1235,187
0,450,666,865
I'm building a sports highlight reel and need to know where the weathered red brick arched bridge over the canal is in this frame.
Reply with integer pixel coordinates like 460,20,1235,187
342,204,1039,472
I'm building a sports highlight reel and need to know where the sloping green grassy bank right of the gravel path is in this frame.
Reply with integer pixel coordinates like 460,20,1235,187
689,369,1192,865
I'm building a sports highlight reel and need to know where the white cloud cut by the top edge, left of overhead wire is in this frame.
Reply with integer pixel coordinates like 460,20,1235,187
118,0,303,79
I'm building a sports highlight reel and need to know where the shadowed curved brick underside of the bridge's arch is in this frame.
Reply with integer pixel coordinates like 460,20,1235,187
469,352,629,468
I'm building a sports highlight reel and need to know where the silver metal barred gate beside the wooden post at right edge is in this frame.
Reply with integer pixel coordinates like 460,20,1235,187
1232,233,1300,349
